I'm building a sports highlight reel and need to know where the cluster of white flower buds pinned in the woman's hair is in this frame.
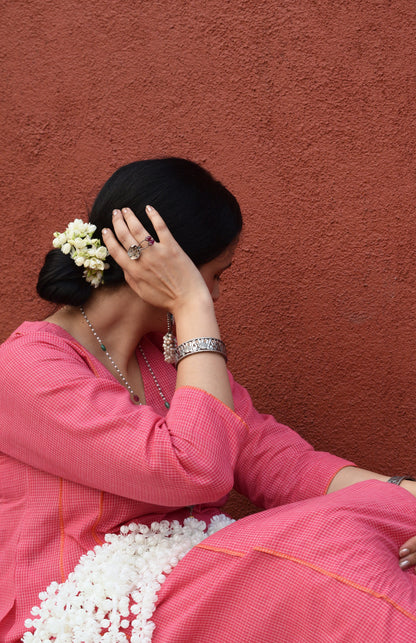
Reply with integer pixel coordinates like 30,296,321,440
53,219,110,288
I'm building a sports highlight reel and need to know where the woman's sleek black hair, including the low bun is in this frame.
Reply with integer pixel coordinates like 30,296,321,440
37,157,242,306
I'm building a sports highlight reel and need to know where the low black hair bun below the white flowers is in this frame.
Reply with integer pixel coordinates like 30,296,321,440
36,248,92,306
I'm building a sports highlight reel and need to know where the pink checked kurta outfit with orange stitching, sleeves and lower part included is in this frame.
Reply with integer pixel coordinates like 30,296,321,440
0,322,416,643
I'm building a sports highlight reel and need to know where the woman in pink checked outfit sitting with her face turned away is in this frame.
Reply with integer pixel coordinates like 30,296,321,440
0,158,416,643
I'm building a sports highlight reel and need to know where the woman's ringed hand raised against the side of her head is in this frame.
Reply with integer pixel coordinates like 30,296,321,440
102,206,211,315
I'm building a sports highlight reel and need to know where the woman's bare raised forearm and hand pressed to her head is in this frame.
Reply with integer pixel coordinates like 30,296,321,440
103,206,233,409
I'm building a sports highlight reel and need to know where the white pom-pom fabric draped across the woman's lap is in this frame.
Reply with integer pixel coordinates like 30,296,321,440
22,514,234,643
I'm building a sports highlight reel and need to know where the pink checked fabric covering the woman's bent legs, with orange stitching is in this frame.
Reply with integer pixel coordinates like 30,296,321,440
154,481,416,643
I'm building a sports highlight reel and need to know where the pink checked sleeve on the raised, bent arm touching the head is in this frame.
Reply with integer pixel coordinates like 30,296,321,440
0,324,247,506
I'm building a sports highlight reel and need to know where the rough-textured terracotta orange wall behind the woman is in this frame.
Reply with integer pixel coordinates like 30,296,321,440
0,0,416,484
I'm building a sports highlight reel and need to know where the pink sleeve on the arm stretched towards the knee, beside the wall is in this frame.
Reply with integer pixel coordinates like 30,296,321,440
230,376,353,509
